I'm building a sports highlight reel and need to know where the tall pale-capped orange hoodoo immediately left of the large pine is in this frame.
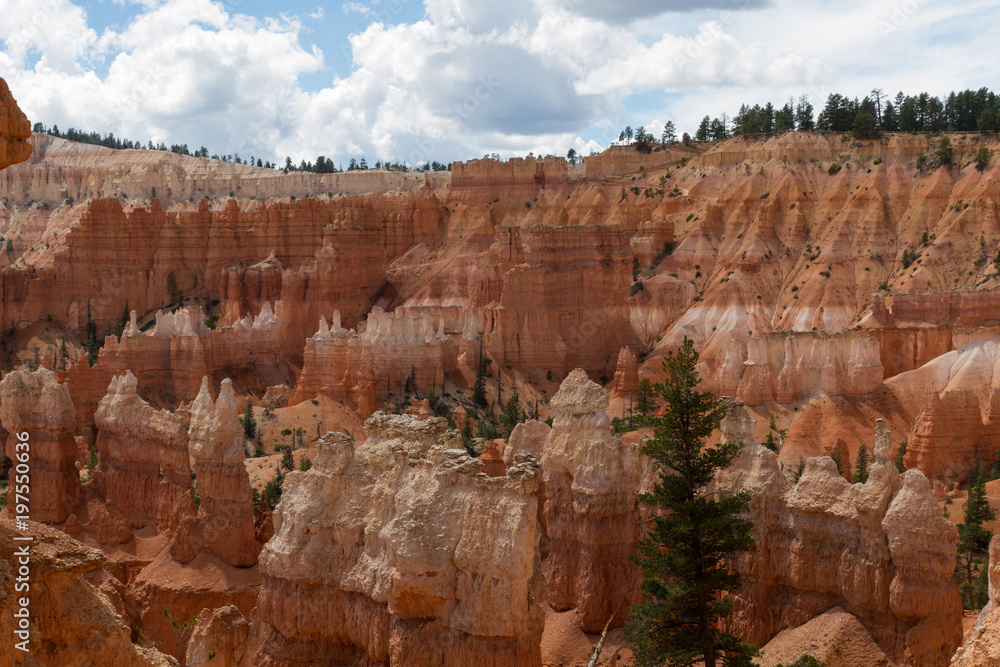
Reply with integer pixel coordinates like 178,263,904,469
544,369,643,632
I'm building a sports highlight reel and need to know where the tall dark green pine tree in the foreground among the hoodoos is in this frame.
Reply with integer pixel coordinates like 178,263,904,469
625,338,757,667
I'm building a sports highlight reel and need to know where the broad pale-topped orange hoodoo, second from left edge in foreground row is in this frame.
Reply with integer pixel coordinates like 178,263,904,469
92,372,194,532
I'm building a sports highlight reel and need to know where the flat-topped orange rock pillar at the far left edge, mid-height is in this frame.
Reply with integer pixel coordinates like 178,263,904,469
0,368,81,523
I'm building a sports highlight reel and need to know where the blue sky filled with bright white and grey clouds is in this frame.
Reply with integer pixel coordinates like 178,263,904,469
0,0,1000,165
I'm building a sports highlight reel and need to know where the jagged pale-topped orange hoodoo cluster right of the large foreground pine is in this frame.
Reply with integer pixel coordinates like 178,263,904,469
716,404,962,666
